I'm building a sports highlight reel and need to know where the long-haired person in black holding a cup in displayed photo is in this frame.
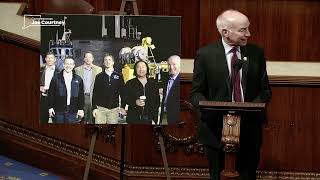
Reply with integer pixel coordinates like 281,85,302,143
124,61,160,124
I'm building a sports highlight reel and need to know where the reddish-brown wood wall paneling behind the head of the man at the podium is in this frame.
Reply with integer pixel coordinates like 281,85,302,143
200,0,320,61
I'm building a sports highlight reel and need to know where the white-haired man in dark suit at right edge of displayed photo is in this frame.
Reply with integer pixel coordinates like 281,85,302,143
161,55,181,125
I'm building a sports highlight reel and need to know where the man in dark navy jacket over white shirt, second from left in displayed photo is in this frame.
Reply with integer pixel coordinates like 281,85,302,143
48,57,84,123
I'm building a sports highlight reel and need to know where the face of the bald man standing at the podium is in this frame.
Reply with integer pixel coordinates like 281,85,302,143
224,18,251,46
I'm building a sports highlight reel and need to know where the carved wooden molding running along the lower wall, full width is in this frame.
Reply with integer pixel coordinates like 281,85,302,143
0,120,320,180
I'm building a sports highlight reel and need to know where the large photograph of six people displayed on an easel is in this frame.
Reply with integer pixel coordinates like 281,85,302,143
40,14,181,124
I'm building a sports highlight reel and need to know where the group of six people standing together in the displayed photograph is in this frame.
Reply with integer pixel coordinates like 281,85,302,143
40,52,181,124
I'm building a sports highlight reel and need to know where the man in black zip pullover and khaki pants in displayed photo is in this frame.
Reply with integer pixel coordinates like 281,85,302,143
92,54,126,124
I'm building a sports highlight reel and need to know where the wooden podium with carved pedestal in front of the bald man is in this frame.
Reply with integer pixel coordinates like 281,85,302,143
199,101,265,180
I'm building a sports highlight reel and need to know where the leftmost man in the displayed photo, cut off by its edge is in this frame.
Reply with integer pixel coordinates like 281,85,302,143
40,52,58,123
